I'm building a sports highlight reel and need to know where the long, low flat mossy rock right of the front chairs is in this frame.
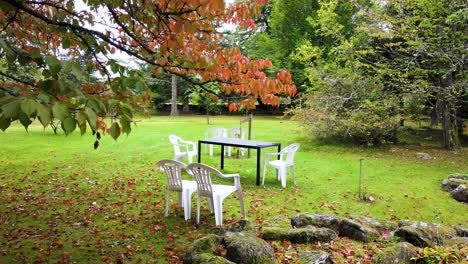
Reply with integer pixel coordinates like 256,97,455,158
262,226,337,243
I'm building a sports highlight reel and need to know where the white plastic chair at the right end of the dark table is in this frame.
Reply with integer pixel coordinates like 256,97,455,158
262,143,300,188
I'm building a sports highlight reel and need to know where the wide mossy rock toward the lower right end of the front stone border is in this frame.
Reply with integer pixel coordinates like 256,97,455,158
395,221,456,248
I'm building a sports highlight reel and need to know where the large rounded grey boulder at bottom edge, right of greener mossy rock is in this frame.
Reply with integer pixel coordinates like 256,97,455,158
225,233,275,264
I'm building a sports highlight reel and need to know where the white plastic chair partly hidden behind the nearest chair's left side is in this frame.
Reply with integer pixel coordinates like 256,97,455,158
156,160,197,221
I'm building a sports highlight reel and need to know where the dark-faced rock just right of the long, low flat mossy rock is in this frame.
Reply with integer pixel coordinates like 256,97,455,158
338,219,380,243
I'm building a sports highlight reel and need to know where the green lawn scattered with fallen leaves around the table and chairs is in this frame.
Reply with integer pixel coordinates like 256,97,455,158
0,116,468,263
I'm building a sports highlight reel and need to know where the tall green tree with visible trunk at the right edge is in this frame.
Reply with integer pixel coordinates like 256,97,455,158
356,0,468,149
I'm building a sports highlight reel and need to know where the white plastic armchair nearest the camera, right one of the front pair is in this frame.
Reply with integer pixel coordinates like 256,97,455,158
187,163,245,226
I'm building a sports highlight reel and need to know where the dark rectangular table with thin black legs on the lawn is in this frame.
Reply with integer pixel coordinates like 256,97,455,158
198,138,281,185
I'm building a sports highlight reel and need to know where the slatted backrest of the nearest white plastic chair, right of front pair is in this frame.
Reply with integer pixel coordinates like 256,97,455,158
187,163,221,197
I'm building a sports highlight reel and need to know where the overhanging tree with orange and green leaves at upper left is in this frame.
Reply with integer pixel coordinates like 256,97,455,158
0,0,295,138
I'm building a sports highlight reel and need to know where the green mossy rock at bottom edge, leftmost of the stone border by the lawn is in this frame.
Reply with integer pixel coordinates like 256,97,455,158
182,234,225,264
